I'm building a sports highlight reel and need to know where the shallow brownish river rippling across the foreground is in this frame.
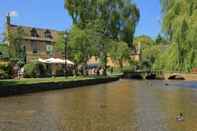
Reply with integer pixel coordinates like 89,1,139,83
0,80,197,131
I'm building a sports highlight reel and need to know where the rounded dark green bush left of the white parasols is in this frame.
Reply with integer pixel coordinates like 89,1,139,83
24,62,47,78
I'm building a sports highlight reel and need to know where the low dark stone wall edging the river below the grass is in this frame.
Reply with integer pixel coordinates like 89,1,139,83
0,77,119,97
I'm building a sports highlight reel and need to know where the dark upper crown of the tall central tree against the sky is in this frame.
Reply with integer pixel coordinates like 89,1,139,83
65,0,140,46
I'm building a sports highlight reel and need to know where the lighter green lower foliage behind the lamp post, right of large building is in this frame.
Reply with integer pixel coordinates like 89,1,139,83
68,21,117,74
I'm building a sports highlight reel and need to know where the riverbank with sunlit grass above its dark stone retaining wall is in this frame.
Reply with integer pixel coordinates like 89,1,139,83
0,76,119,97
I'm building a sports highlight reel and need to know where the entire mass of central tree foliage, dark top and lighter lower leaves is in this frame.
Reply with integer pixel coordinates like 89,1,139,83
65,0,139,74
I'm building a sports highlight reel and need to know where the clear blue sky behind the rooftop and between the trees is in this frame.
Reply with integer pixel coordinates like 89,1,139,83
0,0,161,40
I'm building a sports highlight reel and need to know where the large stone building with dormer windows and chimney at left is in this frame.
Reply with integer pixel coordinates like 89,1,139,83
6,15,63,63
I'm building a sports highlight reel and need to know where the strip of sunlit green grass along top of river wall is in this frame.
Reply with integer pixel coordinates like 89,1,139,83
0,76,117,87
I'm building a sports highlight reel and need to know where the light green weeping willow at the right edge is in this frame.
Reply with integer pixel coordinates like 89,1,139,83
161,0,197,71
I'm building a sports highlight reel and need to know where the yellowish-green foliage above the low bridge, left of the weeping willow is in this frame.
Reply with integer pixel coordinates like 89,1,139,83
134,35,168,71
